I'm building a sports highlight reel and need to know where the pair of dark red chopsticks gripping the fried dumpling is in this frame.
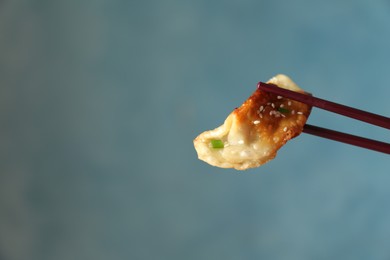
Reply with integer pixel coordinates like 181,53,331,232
257,82,390,154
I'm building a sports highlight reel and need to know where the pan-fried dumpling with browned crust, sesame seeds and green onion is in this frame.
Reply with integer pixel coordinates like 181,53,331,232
194,74,311,170
